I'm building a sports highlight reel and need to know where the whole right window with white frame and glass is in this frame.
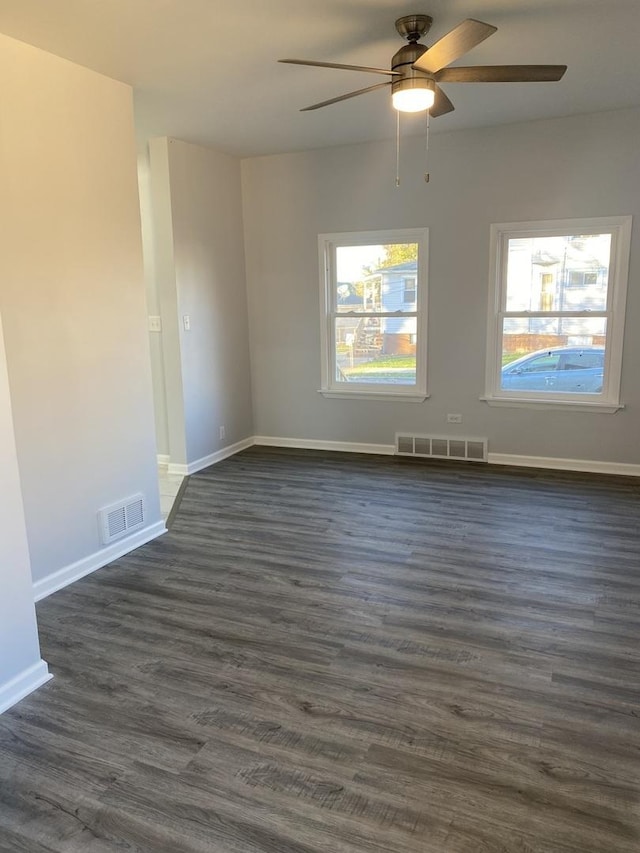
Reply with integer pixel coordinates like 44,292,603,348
484,216,631,411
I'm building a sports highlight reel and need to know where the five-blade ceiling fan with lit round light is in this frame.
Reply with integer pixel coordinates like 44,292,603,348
278,15,567,117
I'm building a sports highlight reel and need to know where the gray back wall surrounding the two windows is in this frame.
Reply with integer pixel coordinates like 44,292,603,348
242,109,640,463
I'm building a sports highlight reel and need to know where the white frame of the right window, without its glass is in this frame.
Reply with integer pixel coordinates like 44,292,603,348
481,216,632,413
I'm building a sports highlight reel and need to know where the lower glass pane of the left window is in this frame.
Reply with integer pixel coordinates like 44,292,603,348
335,317,417,385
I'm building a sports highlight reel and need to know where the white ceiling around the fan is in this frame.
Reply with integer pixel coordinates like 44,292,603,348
0,0,640,156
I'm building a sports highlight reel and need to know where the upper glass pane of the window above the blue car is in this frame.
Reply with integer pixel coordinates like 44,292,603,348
507,234,611,312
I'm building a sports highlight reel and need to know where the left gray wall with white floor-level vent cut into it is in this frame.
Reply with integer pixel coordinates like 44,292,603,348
0,36,161,581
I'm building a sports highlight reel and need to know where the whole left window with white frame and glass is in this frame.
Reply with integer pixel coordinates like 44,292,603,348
318,228,427,401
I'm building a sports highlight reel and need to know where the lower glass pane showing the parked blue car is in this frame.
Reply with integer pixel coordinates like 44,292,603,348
500,316,606,394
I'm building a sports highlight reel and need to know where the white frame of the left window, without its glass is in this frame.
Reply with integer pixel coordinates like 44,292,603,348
318,228,429,403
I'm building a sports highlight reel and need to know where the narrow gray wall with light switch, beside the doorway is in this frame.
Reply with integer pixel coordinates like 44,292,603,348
150,139,253,465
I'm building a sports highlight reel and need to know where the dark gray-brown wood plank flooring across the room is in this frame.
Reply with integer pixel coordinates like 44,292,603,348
0,448,640,853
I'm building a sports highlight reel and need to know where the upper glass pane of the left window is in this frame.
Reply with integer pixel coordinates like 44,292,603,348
336,243,418,313
